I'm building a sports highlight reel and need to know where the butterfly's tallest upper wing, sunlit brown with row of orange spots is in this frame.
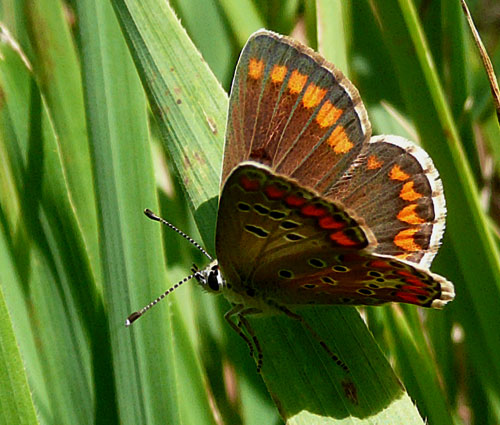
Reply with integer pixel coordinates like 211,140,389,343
222,31,371,192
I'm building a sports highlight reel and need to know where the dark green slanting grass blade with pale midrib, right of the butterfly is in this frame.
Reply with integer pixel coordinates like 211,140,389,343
373,1,500,394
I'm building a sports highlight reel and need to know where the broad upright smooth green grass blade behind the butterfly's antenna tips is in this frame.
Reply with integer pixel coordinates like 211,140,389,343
74,2,215,424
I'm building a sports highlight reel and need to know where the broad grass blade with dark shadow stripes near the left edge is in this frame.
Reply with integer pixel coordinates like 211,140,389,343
0,24,103,424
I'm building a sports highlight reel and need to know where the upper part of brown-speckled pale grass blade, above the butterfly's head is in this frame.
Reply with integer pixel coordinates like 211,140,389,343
113,0,227,253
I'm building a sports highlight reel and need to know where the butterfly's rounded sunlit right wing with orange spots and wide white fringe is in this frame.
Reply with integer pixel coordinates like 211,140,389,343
324,136,446,267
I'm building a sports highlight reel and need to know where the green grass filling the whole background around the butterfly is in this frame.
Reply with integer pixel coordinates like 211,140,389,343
0,0,500,424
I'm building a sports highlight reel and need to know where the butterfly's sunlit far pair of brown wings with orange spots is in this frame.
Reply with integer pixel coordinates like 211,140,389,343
222,31,446,267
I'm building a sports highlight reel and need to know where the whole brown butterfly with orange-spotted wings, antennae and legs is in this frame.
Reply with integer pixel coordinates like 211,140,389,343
127,30,455,371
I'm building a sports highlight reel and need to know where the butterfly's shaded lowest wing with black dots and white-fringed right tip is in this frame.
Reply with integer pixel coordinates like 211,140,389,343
253,250,454,308
